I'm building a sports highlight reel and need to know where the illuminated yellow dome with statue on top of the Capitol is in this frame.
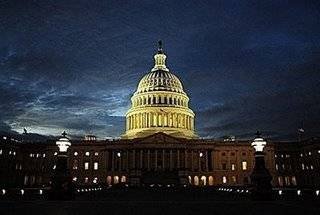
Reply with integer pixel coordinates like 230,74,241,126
122,41,197,139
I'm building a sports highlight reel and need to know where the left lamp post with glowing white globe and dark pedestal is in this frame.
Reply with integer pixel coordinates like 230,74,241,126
49,131,74,200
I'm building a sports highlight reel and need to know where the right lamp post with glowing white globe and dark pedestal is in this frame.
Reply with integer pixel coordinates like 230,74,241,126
250,131,272,200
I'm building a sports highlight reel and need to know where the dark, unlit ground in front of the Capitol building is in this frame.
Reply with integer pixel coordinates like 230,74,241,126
0,188,320,215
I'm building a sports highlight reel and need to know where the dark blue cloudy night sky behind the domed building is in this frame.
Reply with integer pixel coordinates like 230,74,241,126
0,0,320,139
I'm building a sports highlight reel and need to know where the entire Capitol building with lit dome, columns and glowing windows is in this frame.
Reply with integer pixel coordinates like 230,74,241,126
0,42,320,187
